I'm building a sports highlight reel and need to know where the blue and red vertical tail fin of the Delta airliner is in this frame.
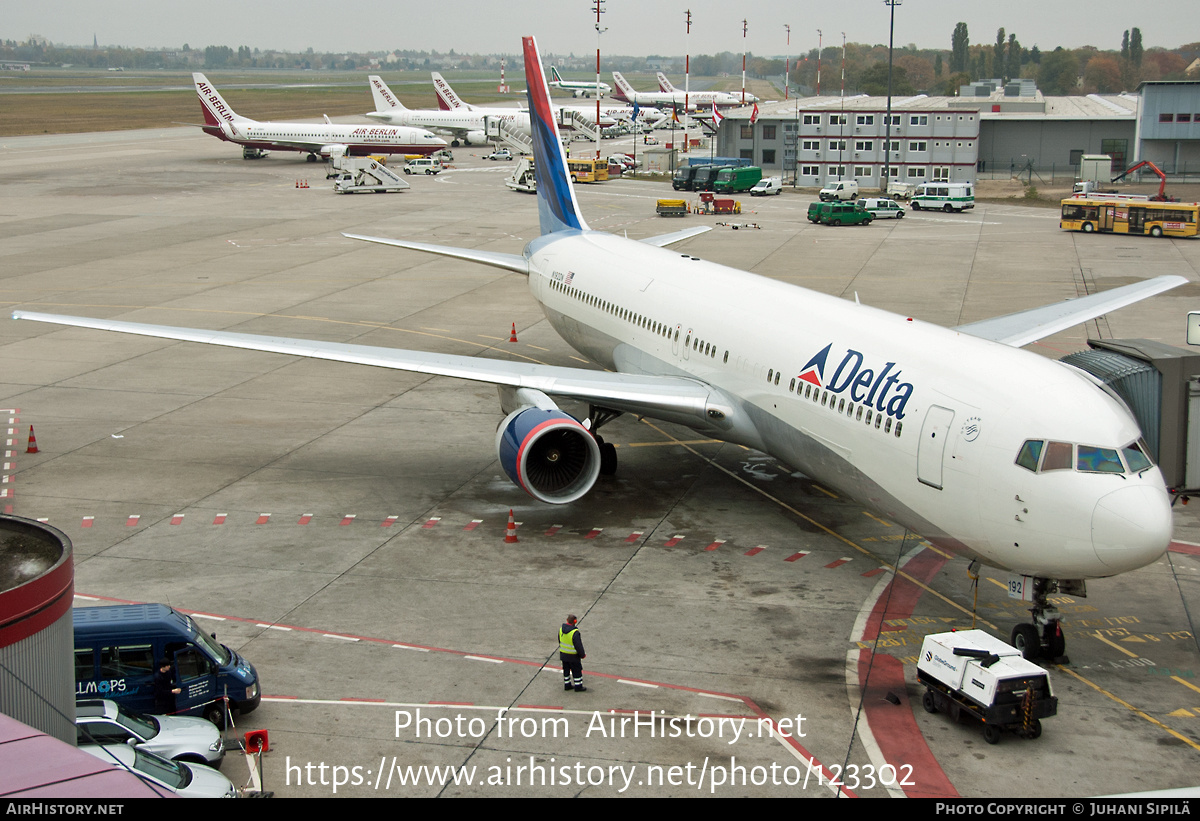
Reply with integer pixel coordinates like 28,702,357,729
521,37,588,234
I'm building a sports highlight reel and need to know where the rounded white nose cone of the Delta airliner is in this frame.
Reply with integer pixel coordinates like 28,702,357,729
1092,485,1171,573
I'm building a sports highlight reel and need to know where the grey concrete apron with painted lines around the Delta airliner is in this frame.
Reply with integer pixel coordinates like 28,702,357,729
0,128,1200,797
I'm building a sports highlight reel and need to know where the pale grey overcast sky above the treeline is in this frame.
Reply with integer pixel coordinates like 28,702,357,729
0,0,1200,55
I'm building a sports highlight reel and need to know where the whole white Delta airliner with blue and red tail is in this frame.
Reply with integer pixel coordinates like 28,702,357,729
13,37,1186,657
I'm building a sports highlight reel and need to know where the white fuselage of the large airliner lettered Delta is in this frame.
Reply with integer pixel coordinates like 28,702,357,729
527,232,1170,579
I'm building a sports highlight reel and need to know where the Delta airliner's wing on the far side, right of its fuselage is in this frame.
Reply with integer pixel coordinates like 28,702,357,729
954,276,1187,348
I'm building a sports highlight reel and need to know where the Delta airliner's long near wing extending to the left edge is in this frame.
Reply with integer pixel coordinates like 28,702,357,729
12,311,718,426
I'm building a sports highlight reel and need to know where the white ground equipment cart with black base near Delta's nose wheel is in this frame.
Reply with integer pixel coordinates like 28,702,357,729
917,630,1058,744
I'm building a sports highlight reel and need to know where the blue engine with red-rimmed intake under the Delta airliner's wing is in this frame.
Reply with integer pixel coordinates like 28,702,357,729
496,406,600,504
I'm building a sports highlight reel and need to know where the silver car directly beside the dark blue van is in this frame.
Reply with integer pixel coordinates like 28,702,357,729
76,699,224,767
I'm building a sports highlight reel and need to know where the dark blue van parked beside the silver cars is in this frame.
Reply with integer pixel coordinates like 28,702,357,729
73,604,262,726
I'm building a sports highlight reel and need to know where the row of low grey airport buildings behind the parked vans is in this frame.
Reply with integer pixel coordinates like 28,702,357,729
715,80,1200,188
